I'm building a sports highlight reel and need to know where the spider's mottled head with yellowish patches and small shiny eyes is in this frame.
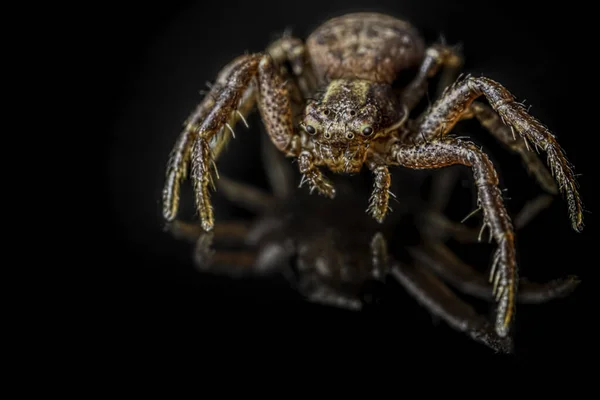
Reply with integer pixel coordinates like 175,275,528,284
301,79,407,148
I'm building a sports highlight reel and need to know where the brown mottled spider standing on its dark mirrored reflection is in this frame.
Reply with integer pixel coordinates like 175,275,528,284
163,13,583,337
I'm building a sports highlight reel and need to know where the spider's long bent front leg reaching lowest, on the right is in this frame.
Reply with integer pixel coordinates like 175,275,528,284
390,137,518,336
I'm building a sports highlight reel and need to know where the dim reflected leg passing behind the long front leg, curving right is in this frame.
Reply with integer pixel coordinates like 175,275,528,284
409,242,580,304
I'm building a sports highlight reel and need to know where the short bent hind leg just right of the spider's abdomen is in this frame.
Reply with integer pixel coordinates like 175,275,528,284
402,44,462,111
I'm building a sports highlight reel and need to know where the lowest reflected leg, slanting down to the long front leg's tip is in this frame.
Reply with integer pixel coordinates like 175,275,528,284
390,262,512,353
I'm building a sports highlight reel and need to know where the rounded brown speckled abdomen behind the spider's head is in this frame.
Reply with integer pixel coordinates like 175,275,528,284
306,13,424,84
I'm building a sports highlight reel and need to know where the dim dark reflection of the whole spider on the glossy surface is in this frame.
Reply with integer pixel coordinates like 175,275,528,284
168,140,579,352
